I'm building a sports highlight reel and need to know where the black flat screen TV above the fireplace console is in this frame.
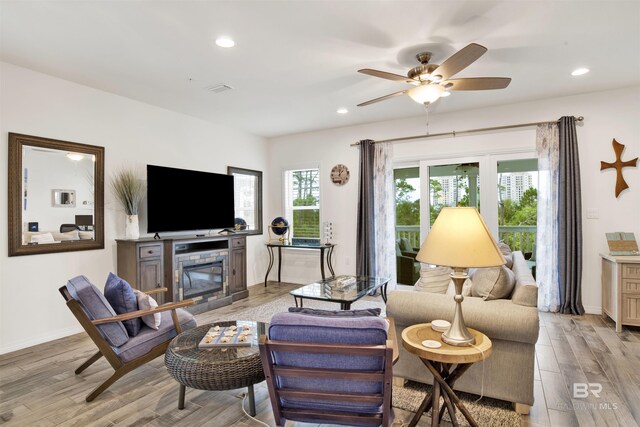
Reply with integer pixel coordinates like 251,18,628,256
147,165,234,233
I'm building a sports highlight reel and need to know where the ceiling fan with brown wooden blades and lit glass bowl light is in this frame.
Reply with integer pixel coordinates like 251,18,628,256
358,43,511,107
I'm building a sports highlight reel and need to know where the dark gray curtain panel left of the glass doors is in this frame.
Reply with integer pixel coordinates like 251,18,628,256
356,139,376,276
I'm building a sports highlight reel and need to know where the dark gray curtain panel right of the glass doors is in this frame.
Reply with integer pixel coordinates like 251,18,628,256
558,117,584,314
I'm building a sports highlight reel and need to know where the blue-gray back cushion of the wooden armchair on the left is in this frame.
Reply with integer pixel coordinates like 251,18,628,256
67,276,129,347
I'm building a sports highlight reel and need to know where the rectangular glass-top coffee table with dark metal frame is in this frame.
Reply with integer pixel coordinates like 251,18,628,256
289,276,389,310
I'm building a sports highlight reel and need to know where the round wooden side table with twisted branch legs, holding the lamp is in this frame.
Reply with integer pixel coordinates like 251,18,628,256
402,323,491,427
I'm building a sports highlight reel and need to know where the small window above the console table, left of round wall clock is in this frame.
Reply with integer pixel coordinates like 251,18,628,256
284,168,320,239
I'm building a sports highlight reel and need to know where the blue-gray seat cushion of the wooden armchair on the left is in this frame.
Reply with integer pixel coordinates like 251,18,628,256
114,308,197,363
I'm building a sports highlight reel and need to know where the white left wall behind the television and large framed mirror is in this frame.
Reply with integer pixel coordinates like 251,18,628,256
0,63,270,353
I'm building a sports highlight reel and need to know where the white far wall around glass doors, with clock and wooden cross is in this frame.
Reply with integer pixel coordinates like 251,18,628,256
266,87,640,313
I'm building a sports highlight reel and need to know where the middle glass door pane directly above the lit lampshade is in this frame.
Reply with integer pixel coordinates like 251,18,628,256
429,163,480,225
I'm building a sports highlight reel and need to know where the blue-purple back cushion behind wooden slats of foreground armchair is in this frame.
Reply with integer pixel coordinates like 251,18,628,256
269,313,389,413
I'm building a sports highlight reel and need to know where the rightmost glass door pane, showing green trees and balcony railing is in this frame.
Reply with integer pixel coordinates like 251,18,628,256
497,159,538,254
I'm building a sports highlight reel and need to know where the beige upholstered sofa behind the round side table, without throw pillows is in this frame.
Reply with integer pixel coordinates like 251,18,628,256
387,252,539,413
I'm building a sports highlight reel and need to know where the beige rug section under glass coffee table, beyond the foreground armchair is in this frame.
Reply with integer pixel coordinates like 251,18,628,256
228,295,385,323
